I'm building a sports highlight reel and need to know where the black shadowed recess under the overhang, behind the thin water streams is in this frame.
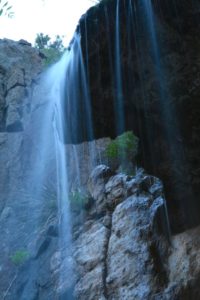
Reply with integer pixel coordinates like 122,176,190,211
63,0,200,233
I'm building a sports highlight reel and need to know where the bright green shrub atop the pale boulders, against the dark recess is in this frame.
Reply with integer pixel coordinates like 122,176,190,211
105,131,139,160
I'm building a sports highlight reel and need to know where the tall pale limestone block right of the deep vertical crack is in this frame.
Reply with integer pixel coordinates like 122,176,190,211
106,195,164,300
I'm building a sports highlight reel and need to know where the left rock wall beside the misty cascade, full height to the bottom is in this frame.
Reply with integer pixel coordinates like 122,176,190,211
0,39,42,299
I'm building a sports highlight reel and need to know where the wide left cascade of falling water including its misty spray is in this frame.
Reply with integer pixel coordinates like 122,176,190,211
0,29,96,299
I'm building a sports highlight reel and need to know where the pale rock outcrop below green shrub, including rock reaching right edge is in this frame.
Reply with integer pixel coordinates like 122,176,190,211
74,165,200,300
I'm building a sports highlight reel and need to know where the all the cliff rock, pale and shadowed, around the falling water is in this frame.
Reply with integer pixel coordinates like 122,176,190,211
0,1,200,300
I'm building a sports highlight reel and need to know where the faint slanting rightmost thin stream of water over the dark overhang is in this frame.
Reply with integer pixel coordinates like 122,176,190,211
142,0,196,224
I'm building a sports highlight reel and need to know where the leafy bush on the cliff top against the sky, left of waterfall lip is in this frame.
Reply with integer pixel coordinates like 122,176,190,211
35,33,65,66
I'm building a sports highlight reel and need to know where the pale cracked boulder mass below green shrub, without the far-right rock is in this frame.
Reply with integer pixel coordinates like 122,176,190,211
75,165,169,300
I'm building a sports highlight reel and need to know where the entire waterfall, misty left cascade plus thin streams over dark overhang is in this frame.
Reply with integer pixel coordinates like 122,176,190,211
0,0,198,300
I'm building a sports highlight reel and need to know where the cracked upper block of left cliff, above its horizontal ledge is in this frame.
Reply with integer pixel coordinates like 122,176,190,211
0,39,42,132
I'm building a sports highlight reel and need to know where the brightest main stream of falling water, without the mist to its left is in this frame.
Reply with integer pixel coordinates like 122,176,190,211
48,34,94,298
